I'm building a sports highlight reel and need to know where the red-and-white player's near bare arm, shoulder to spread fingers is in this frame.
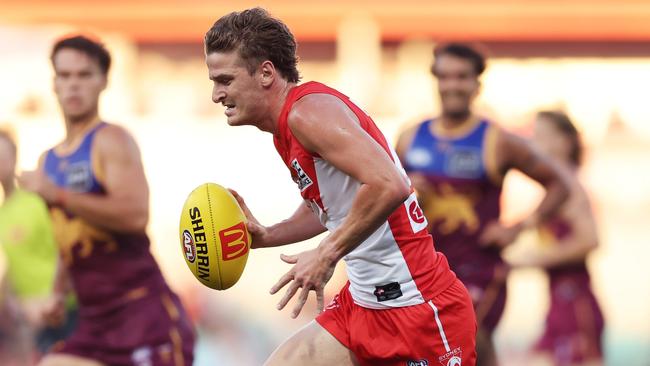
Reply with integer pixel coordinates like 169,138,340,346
271,94,410,317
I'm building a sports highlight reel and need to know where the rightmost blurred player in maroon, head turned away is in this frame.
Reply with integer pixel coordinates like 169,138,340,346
512,111,604,366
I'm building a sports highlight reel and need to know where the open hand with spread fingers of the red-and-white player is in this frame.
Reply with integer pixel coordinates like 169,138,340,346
271,248,335,319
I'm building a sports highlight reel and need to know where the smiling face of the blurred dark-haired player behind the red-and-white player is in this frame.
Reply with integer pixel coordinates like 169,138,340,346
434,55,480,117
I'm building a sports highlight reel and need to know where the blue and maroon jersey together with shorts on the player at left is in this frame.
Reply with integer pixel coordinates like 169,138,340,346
44,123,194,366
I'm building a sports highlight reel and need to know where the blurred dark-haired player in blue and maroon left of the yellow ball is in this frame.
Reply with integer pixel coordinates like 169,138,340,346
20,36,194,366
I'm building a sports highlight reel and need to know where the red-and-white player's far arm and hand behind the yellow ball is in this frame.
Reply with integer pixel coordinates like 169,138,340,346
230,189,327,249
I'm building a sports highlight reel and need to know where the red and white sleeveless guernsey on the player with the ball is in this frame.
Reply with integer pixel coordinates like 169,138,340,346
274,82,456,309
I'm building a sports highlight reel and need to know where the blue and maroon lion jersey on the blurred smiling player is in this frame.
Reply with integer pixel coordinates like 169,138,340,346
403,120,502,280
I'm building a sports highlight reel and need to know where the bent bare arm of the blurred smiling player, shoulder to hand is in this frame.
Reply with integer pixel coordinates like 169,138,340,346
480,130,572,247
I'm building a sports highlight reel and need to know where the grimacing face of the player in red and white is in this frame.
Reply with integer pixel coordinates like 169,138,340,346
206,51,265,126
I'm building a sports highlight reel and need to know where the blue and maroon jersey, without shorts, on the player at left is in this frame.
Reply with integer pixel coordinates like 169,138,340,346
44,122,167,315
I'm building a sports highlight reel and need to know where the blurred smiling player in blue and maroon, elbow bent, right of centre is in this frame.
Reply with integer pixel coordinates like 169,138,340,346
397,43,568,365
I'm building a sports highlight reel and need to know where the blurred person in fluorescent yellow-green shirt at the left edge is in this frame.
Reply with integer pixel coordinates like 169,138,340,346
0,129,76,365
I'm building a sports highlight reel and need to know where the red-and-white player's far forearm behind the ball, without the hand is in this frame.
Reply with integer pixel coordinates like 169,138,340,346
266,204,327,247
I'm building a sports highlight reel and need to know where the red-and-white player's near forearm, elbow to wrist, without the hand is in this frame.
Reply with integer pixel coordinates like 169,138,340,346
319,182,410,263
